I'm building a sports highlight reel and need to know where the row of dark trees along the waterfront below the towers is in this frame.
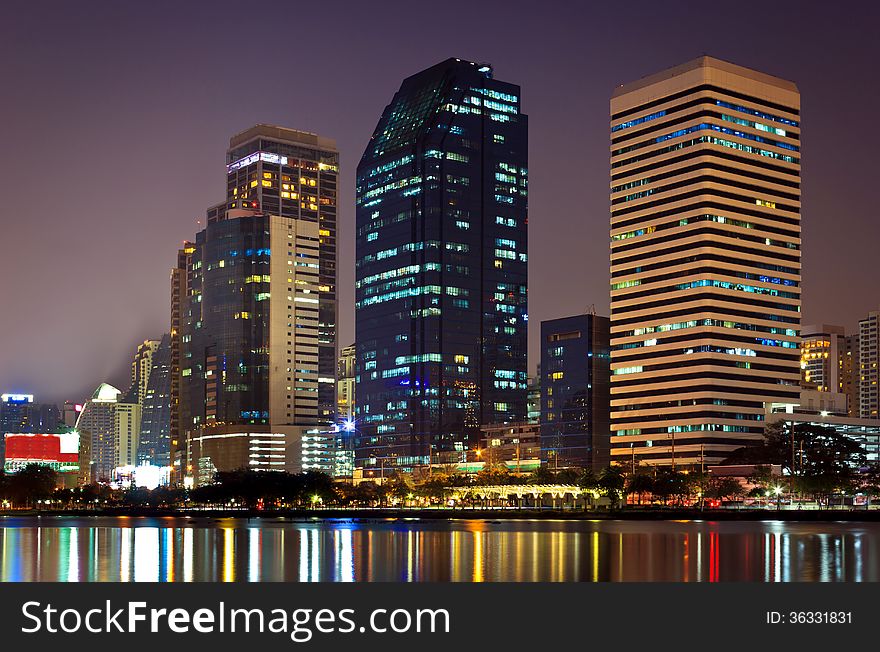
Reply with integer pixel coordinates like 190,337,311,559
0,424,880,507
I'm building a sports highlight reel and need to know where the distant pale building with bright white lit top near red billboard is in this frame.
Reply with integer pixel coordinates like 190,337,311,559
76,383,141,482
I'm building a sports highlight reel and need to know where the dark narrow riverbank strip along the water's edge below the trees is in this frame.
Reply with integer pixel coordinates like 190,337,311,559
0,507,880,523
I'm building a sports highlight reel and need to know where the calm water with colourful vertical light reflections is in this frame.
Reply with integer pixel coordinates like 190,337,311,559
0,517,880,582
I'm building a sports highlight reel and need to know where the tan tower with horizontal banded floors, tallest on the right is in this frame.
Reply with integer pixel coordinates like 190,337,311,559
611,57,801,467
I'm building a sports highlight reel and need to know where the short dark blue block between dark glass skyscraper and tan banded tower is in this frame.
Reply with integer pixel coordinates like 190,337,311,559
540,314,611,470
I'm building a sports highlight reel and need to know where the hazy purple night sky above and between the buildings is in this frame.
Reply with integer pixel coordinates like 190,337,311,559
0,0,880,402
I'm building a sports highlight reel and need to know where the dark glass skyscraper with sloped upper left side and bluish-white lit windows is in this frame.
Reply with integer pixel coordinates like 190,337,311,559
354,59,528,467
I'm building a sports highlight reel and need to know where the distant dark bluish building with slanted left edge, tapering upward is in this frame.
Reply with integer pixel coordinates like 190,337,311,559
137,334,171,466
